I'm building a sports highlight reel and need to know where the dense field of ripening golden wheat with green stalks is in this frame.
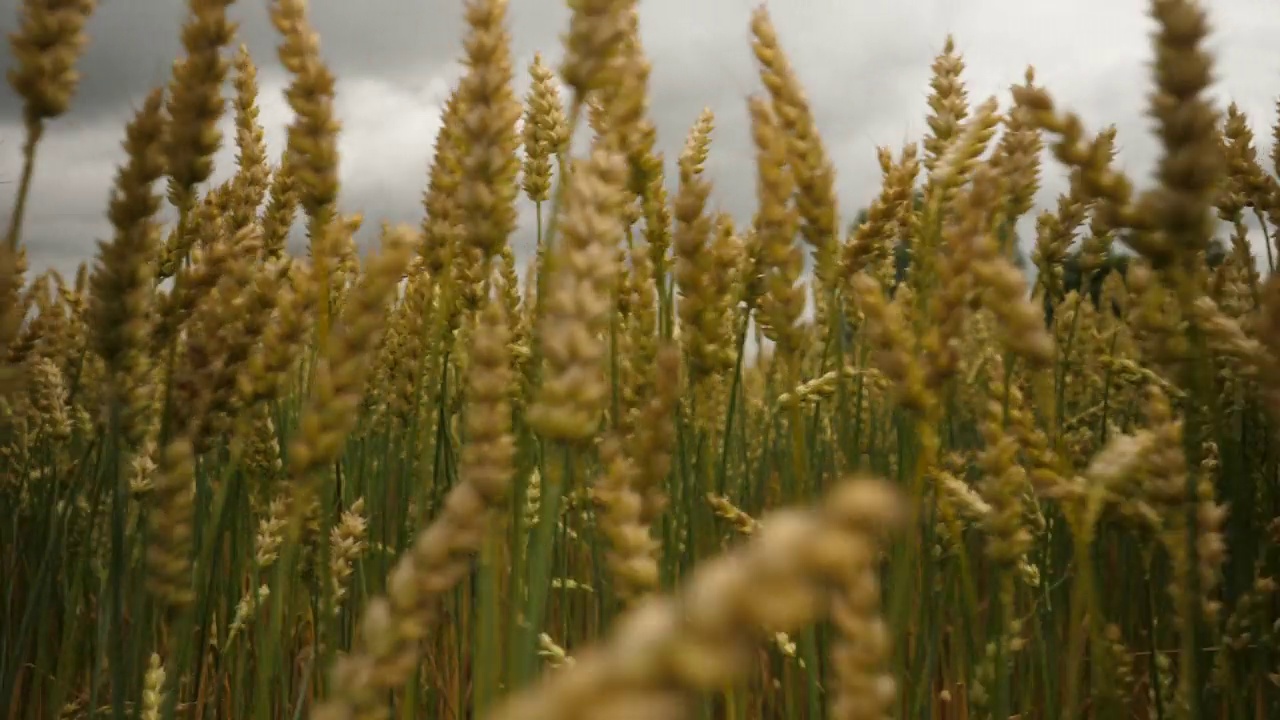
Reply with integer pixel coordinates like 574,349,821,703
0,0,1280,720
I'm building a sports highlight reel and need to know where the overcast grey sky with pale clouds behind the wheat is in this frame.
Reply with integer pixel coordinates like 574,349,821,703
0,0,1280,280
